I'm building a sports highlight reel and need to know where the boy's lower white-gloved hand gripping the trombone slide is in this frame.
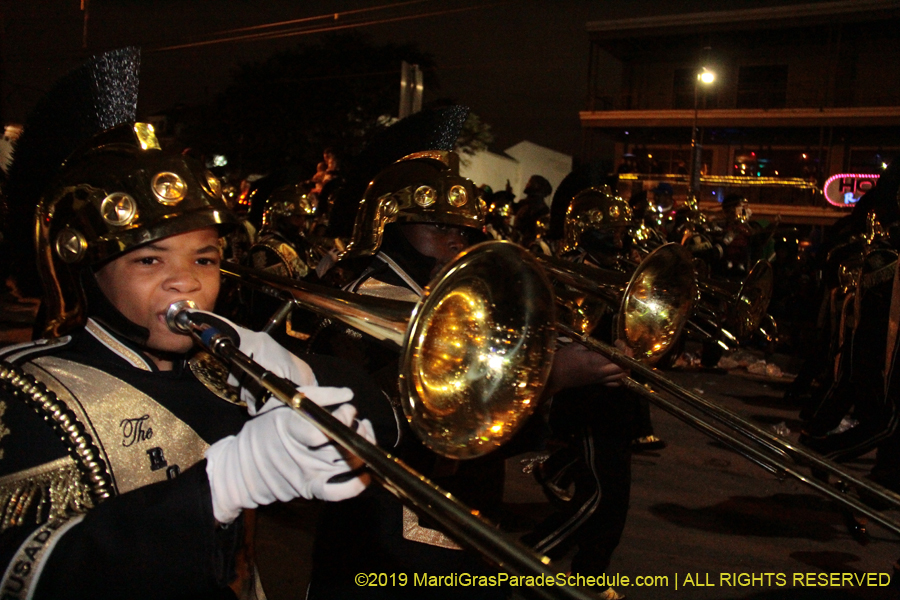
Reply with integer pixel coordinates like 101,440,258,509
206,387,375,523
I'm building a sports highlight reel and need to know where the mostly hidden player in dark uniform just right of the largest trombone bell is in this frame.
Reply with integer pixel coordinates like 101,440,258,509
526,186,648,599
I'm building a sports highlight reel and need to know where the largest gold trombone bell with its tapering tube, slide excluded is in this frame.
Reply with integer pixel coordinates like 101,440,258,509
221,241,556,459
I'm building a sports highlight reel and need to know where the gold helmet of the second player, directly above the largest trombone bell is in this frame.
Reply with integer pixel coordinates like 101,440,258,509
349,150,485,256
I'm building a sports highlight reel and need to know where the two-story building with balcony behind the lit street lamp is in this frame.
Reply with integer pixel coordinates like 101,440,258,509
580,0,900,223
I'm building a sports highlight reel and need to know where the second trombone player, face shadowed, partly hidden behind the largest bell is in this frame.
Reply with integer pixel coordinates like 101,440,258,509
296,151,625,600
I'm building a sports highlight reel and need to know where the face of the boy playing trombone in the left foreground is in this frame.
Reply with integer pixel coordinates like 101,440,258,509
96,227,220,353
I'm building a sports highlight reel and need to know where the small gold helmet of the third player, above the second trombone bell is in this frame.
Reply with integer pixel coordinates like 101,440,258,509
560,186,631,252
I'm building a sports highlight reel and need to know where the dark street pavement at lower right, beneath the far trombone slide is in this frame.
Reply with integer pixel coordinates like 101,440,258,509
596,364,900,600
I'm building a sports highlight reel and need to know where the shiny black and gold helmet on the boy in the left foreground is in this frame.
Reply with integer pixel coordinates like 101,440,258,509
35,123,237,337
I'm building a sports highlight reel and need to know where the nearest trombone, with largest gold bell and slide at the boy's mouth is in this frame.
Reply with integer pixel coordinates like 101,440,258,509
214,242,587,600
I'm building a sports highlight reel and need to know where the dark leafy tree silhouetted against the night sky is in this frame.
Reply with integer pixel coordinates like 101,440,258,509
182,32,437,175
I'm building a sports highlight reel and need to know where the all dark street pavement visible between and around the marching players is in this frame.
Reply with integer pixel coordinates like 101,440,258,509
0,292,900,600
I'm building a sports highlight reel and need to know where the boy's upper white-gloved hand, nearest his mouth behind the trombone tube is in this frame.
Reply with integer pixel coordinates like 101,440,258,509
180,309,316,415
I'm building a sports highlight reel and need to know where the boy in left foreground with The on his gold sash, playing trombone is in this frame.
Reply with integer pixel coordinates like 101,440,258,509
0,49,374,599
